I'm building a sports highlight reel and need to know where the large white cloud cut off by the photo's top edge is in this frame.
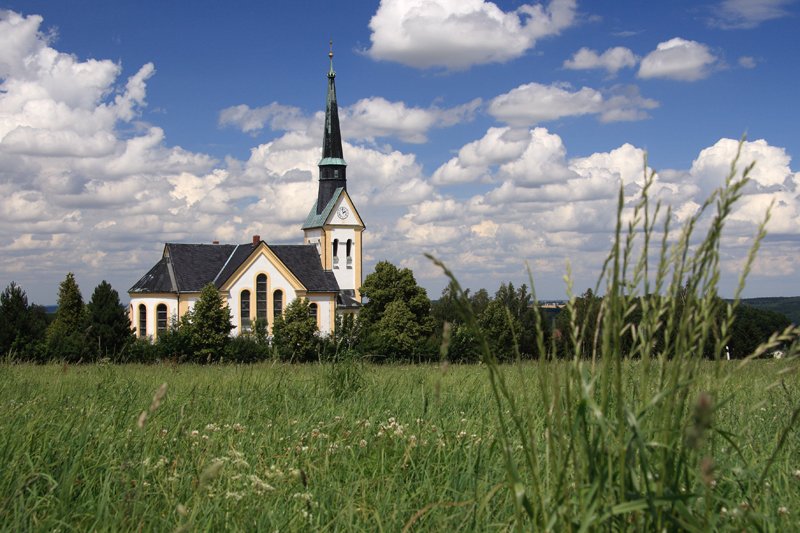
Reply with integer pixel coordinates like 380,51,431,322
366,0,575,70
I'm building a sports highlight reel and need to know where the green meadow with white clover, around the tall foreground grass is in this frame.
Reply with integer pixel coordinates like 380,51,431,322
0,361,800,531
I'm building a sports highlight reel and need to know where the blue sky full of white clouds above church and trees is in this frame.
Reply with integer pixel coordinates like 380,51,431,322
0,0,800,304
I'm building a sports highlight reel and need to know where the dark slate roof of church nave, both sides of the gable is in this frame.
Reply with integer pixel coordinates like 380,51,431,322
129,243,339,293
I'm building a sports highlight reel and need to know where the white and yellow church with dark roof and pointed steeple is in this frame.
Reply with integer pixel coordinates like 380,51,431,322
128,48,365,338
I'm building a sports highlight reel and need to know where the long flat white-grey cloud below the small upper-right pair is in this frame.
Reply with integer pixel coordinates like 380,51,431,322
488,82,658,126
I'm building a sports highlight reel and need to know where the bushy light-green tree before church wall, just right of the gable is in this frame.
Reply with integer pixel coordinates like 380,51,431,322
272,298,318,362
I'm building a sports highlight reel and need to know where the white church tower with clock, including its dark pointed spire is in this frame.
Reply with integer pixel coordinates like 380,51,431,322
303,43,364,307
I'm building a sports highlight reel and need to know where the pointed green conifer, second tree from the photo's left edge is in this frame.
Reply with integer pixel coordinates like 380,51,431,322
46,272,88,362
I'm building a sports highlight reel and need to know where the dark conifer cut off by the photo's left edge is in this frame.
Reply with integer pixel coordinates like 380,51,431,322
0,281,47,359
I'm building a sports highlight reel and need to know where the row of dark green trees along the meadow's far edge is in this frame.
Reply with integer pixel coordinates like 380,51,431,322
0,261,789,363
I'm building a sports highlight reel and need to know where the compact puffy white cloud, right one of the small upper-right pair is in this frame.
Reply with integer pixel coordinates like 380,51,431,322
638,37,718,81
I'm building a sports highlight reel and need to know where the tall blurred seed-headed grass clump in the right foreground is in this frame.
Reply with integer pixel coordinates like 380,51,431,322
434,143,800,531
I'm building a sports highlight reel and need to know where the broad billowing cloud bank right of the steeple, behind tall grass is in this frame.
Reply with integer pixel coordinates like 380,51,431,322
402,127,800,289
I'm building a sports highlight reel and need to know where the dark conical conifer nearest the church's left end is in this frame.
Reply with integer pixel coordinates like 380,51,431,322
86,280,134,356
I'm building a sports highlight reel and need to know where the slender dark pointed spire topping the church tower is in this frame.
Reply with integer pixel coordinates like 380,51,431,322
317,41,347,214
